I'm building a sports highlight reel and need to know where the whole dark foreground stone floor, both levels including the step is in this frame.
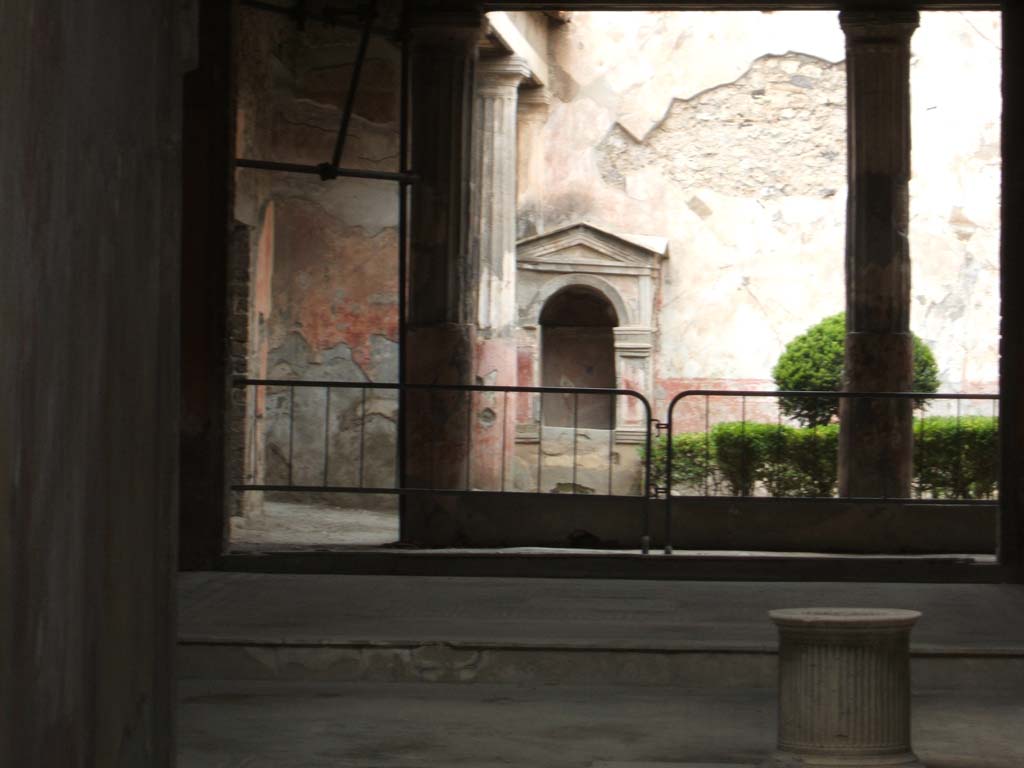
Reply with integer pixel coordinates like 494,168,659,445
178,573,1024,768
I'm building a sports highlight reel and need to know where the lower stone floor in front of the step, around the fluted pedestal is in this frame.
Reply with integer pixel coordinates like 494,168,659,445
178,680,1024,768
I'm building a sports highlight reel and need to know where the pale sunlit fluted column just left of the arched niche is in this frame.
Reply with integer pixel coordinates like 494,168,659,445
470,55,529,490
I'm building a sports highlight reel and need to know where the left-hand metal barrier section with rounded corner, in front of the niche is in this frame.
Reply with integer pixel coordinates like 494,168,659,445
231,378,651,498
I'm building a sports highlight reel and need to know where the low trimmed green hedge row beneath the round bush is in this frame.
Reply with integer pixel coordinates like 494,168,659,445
651,416,998,499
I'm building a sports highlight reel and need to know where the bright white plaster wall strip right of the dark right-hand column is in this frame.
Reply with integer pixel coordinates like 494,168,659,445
910,12,1001,391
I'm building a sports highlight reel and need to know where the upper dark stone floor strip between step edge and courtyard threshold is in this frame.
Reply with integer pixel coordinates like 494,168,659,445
179,572,1024,652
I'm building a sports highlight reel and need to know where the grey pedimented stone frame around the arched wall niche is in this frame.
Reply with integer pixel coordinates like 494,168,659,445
516,222,668,443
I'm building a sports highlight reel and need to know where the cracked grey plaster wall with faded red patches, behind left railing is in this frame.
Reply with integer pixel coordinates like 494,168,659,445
236,15,399,506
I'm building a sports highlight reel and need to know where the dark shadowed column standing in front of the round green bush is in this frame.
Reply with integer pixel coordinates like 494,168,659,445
839,11,919,505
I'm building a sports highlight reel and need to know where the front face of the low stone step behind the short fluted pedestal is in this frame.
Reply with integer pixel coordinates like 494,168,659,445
178,638,1024,691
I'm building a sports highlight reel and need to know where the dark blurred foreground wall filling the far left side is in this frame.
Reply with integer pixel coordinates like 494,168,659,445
0,0,187,768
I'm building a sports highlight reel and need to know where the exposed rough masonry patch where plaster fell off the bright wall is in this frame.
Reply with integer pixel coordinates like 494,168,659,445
597,53,846,202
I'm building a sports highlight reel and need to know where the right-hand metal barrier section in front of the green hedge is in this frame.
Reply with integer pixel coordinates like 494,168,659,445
652,389,999,551
